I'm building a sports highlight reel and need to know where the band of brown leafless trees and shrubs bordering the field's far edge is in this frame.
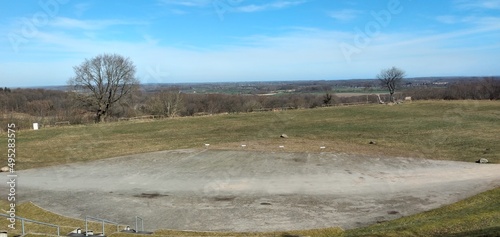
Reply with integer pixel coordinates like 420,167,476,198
0,78,500,130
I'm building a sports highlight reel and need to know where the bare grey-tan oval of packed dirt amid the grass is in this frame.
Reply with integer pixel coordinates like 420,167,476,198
0,150,500,231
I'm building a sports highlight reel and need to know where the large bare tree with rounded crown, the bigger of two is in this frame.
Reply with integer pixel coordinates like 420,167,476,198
68,54,139,122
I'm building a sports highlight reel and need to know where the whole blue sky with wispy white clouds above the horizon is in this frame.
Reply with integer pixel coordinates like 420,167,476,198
0,0,500,87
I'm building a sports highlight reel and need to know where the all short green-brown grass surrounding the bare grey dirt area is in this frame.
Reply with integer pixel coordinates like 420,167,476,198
0,101,500,236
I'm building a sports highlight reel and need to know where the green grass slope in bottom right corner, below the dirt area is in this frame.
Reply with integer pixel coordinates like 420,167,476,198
343,188,500,237
